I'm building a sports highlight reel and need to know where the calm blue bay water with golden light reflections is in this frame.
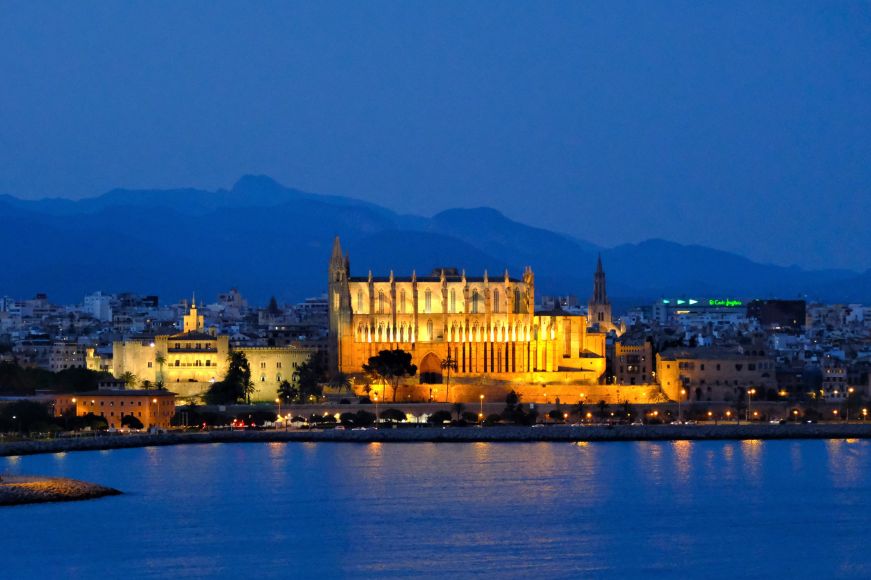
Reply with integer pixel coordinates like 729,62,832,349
0,441,871,578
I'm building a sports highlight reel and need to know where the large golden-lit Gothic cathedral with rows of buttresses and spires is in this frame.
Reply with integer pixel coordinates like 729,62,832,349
328,237,611,402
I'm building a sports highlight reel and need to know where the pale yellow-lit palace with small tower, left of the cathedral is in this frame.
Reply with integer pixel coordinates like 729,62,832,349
93,300,313,401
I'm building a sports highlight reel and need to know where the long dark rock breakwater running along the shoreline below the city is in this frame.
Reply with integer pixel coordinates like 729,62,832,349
0,423,871,456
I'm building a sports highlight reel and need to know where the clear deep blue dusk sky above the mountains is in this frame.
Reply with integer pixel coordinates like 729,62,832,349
0,0,871,269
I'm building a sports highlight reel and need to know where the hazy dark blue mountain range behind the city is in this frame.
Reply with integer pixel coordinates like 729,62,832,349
0,176,871,303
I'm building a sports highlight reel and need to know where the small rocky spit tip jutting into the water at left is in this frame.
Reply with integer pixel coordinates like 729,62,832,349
0,475,121,506
